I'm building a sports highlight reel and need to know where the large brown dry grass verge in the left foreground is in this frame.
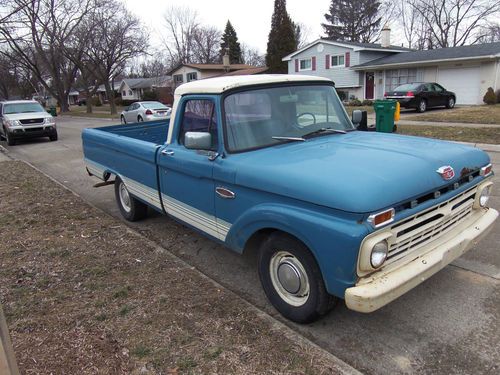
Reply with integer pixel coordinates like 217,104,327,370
0,161,348,374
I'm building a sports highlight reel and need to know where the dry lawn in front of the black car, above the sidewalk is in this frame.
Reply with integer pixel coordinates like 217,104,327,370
408,104,500,125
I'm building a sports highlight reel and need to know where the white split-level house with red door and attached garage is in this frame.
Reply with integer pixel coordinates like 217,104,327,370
283,29,500,104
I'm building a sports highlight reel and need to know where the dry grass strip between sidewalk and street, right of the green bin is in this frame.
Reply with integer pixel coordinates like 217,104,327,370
397,125,500,144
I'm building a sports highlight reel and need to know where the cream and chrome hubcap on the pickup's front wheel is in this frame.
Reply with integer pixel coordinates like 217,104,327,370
269,251,310,306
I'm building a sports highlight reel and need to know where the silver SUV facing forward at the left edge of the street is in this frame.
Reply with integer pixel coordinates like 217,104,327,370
0,100,57,146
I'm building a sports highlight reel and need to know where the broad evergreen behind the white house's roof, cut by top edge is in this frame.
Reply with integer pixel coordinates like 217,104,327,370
321,0,382,43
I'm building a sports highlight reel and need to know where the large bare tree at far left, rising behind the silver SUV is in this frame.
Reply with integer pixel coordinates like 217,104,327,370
0,0,100,112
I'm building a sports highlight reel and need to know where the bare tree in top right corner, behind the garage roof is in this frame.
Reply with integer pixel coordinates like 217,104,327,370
407,0,500,48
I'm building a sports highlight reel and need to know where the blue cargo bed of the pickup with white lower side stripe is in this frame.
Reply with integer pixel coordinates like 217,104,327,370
82,120,170,211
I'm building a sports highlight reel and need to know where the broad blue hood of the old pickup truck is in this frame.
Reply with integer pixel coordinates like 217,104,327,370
231,131,489,213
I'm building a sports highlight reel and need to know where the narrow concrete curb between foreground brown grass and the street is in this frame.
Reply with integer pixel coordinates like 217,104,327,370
0,151,362,375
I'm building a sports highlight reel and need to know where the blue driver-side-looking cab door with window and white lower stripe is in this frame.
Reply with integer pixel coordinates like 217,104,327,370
158,97,219,238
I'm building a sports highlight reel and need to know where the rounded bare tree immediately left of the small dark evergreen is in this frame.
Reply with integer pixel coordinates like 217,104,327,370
191,26,222,64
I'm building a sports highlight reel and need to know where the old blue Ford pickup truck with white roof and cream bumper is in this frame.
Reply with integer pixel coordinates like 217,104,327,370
82,75,498,323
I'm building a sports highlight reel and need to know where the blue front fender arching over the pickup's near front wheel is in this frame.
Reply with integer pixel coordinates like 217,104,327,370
226,203,368,298
